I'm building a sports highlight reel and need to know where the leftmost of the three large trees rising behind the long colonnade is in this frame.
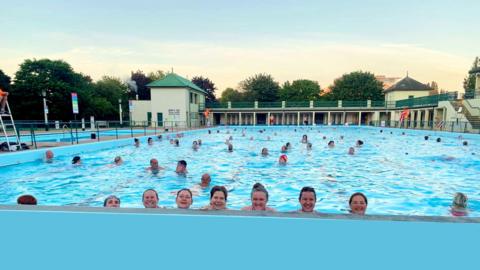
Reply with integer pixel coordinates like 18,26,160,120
240,74,280,101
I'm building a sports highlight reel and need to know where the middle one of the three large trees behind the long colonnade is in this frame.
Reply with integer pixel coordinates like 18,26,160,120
279,80,321,101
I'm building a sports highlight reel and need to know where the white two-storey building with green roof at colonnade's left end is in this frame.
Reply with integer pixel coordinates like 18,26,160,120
130,73,206,127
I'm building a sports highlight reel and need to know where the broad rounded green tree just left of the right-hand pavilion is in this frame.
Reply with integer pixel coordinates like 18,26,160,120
328,71,384,101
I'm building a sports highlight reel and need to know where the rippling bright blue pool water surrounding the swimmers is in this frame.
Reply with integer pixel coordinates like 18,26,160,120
0,127,480,216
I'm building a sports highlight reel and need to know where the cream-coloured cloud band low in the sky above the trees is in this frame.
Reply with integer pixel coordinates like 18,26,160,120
0,33,472,95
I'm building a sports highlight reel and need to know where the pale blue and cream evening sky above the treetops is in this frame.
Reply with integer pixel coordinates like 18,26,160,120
0,0,480,96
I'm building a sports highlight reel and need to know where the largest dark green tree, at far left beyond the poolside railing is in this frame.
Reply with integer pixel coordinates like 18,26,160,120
10,59,92,120
